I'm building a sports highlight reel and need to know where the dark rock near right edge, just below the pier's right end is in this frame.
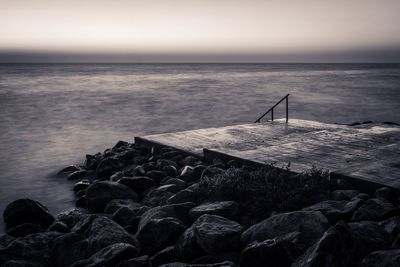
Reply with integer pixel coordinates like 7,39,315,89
351,198,393,221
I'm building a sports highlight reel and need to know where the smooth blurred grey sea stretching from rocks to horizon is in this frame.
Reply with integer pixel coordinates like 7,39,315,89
0,64,400,232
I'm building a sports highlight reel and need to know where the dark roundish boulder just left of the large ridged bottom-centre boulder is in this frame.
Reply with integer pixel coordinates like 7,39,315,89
135,217,186,255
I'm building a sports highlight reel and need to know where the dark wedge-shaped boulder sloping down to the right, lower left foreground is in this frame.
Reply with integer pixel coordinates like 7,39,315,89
85,217,139,254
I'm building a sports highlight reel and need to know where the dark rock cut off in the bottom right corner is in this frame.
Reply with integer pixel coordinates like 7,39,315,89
360,249,400,267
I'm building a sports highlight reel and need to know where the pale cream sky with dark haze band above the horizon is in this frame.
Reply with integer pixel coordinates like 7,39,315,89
0,0,400,62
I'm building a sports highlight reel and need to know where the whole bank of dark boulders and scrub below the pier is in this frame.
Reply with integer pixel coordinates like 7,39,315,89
0,141,400,267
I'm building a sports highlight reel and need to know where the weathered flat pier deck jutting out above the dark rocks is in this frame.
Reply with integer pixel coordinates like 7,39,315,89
135,119,400,190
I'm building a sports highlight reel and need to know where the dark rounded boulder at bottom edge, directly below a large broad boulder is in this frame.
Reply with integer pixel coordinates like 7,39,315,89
240,239,293,267
